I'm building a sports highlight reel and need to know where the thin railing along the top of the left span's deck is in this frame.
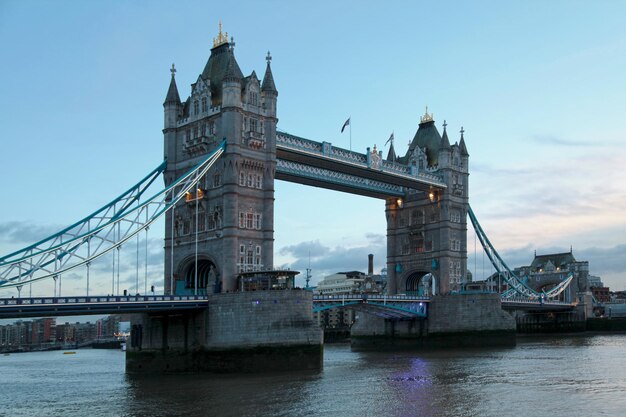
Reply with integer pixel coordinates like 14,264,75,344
0,295,207,306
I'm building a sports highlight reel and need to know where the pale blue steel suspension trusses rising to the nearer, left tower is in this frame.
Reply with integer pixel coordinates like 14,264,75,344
0,141,226,291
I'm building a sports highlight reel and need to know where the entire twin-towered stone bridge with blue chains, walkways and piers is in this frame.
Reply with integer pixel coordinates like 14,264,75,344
0,26,580,370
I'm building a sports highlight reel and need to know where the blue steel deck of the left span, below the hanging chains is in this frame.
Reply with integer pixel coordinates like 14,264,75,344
0,295,208,318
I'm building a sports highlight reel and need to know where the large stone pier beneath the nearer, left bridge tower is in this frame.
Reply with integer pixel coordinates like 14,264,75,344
126,290,323,373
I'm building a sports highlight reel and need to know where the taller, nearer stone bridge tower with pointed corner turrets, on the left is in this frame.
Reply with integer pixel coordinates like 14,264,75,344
163,24,278,294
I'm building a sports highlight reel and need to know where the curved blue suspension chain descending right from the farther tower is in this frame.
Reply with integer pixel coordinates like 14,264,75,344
467,207,574,299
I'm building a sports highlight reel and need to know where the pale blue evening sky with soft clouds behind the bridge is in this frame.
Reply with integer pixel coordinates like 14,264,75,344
0,0,626,296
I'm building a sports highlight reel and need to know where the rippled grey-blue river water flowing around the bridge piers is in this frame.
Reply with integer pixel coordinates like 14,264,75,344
0,335,626,417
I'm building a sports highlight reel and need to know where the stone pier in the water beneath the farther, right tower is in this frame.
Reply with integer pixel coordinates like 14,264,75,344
351,294,515,350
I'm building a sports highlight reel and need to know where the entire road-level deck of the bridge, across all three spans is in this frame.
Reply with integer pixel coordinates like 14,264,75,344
0,294,574,320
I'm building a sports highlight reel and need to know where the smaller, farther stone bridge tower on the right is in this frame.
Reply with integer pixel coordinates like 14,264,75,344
386,109,469,295
